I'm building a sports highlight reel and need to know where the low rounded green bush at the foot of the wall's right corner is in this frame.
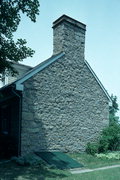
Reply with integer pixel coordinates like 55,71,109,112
86,123,120,155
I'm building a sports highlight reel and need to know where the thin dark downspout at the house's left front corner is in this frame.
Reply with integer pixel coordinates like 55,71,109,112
12,87,22,156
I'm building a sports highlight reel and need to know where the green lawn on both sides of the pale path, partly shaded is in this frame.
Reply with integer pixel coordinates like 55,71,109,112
0,153,120,180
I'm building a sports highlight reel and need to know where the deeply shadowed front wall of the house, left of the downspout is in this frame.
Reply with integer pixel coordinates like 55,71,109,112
0,97,19,159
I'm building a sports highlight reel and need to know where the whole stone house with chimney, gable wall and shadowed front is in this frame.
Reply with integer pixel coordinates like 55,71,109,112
0,15,110,156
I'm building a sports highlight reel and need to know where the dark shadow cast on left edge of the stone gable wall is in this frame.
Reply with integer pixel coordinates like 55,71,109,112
21,81,48,155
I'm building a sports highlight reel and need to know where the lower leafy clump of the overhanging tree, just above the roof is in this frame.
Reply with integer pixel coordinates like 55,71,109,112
0,38,34,75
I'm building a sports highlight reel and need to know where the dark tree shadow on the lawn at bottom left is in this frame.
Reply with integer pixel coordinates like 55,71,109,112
0,162,67,180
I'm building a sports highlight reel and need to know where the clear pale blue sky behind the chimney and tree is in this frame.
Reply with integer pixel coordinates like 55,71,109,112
14,0,120,116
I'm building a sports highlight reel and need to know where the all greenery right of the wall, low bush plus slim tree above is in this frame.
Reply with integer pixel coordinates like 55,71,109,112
86,95,120,155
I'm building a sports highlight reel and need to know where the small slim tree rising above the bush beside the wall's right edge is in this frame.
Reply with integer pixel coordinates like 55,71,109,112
109,94,119,124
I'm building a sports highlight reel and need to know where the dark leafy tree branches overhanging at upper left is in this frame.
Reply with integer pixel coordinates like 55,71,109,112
0,0,40,75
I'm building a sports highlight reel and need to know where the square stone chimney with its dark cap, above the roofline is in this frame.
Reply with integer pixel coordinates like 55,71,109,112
53,15,86,60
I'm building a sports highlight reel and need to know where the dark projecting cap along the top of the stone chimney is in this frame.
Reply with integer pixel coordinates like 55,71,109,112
53,14,86,30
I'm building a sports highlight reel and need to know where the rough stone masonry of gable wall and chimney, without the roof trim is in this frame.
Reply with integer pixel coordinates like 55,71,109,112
21,16,109,155
